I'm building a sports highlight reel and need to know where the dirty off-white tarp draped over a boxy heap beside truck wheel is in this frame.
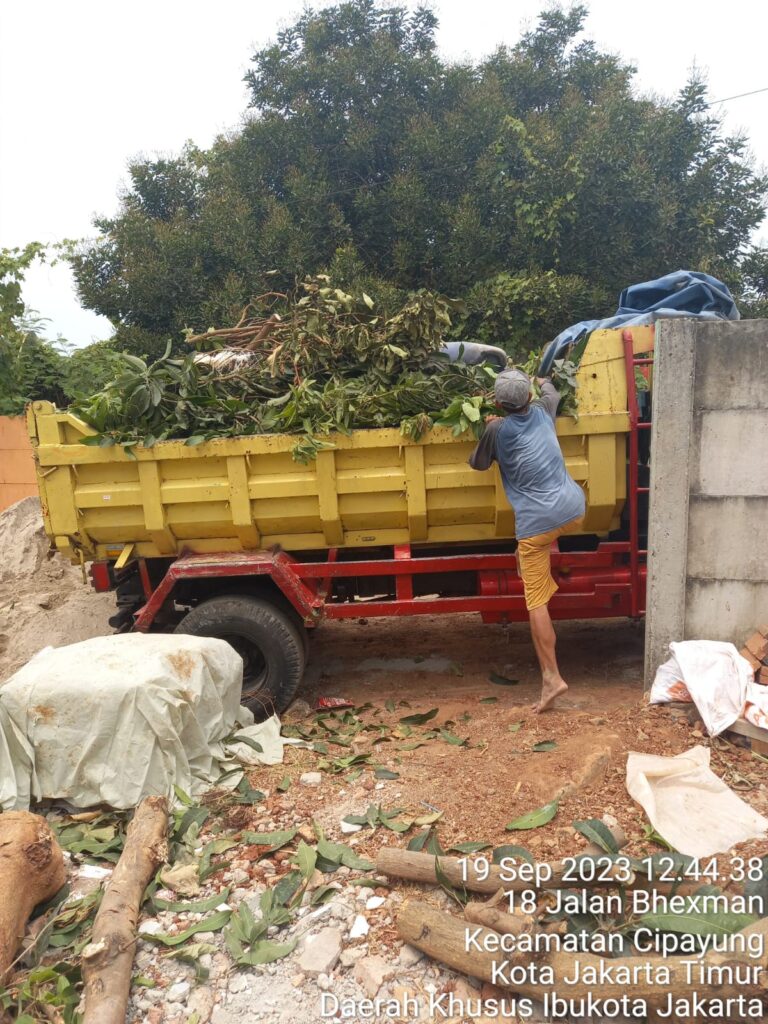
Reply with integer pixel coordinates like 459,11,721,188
0,633,283,810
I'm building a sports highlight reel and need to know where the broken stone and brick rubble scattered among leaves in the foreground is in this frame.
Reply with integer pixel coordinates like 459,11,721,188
94,692,768,1024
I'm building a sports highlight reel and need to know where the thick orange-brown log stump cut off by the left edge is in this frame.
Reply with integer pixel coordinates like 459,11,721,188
0,811,67,981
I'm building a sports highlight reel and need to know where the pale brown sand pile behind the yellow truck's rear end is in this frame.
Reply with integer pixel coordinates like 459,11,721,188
0,498,115,682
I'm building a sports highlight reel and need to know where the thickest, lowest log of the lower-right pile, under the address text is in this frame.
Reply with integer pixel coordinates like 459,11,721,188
396,900,766,1007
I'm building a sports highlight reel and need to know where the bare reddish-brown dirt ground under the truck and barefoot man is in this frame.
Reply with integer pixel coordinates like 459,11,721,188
272,614,768,856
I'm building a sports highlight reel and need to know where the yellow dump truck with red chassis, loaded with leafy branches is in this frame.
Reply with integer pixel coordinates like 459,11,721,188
28,327,653,709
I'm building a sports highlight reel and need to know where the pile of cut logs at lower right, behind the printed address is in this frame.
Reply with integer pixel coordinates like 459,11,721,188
377,847,768,1020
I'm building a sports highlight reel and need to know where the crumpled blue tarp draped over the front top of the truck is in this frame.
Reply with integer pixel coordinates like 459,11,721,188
539,270,739,375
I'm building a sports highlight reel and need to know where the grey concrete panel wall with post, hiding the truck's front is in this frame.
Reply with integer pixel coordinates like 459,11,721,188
645,321,768,686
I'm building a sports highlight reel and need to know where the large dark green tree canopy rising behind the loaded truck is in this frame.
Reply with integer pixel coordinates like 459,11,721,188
67,0,768,360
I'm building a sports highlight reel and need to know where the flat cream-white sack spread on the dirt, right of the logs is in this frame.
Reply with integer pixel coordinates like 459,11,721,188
627,746,768,857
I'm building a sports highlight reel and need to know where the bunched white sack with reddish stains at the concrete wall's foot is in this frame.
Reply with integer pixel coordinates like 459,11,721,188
650,640,755,736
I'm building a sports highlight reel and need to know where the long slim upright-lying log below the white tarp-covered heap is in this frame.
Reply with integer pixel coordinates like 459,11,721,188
82,797,168,1024
